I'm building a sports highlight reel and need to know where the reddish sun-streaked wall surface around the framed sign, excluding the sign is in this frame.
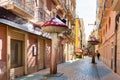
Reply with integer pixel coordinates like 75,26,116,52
27,35,37,73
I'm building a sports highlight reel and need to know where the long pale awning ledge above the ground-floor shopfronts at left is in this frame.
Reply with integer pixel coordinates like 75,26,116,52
0,18,51,39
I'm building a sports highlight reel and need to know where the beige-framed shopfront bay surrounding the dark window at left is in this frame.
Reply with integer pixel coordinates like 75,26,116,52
7,27,26,79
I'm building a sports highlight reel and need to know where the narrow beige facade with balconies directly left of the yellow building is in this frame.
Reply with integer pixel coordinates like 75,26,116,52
64,0,76,61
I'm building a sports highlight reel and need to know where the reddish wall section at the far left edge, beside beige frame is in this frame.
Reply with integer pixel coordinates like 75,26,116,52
0,24,7,80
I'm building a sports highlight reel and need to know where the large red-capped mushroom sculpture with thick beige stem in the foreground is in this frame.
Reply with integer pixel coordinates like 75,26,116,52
42,17,68,74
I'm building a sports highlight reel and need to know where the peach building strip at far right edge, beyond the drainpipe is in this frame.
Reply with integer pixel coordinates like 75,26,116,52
111,0,120,75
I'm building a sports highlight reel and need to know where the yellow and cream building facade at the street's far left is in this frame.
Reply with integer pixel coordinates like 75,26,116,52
75,18,86,53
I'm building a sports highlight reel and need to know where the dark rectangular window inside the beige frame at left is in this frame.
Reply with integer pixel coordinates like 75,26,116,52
11,39,22,68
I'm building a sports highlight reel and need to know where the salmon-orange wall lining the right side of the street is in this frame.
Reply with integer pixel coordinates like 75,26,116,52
101,11,116,67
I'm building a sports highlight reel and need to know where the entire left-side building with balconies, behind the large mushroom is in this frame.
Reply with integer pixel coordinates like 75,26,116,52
0,0,75,80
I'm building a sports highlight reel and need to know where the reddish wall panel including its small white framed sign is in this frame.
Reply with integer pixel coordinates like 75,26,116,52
27,34,38,73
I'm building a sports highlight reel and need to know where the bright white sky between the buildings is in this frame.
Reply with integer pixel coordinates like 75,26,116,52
76,0,96,40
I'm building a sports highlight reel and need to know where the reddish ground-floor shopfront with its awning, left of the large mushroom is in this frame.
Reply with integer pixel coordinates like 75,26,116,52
0,19,51,80
